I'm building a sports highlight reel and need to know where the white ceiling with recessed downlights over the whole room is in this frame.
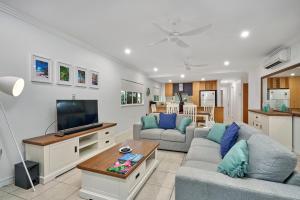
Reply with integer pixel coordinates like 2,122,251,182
0,0,300,82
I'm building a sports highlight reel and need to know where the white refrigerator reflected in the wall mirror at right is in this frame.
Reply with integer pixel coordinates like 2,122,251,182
269,89,290,109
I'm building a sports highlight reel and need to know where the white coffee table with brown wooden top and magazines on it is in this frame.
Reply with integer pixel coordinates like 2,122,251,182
77,140,159,200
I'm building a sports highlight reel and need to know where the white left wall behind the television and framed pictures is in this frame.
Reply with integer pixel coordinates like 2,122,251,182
0,12,161,186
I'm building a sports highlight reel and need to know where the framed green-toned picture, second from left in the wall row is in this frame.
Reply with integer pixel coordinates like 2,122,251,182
56,62,73,85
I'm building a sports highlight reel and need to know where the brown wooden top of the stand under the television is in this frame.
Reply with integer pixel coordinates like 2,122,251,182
23,123,117,146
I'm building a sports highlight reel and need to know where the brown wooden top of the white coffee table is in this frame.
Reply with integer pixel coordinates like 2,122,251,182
77,140,159,179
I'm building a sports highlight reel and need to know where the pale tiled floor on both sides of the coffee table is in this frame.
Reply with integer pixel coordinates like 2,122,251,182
0,150,185,200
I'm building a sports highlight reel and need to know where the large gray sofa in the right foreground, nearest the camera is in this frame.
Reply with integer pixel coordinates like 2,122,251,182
175,124,300,200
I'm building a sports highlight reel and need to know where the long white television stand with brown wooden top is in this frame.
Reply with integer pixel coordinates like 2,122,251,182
23,123,117,184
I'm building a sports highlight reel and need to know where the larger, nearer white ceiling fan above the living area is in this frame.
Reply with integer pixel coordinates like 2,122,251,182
149,22,212,48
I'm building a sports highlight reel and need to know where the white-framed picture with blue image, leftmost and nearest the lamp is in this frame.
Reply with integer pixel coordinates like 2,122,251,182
31,55,52,83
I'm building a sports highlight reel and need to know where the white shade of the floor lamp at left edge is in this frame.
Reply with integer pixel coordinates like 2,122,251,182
0,76,25,97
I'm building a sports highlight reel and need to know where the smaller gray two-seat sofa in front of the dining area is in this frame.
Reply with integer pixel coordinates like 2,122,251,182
133,113,195,152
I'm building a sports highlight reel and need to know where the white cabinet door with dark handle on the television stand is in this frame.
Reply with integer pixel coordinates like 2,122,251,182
49,138,79,172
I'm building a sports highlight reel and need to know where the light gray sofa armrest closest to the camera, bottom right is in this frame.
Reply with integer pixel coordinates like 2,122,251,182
175,167,300,200
